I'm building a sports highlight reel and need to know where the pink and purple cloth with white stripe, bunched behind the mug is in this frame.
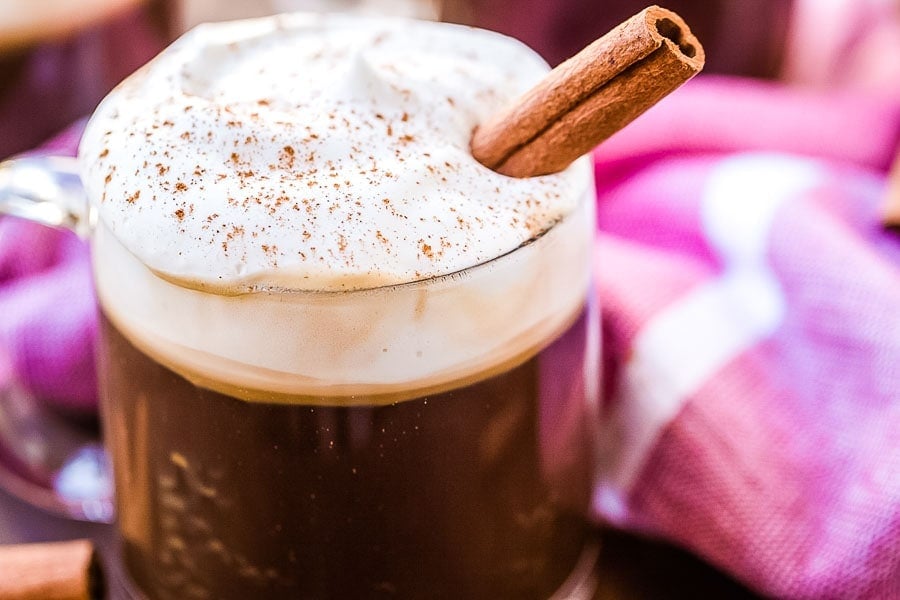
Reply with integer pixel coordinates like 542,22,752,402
0,78,900,598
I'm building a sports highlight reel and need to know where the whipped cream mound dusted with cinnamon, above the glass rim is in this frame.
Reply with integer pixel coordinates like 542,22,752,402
80,14,589,292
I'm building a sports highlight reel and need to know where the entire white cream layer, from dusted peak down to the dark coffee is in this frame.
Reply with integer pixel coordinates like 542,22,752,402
80,15,593,401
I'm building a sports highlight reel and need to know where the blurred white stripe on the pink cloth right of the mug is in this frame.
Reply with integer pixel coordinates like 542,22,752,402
593,153,824,524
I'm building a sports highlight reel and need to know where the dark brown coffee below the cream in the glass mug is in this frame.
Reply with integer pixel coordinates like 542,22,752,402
100,300,597,599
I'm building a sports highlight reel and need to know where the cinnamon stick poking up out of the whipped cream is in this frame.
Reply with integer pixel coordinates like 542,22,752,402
472,6,705,177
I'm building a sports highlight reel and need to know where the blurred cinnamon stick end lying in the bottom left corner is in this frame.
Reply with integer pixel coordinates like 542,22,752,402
0,540,105,600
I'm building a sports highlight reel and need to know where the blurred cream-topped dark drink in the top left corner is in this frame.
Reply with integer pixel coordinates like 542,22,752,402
0,0,177,158
